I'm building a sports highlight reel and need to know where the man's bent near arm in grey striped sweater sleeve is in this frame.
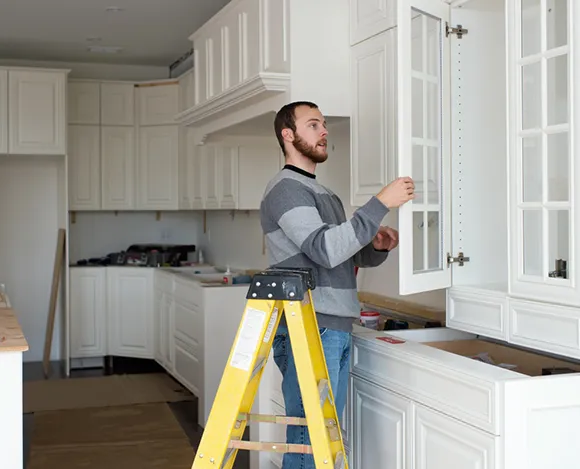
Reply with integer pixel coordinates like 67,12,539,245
264,179,389,269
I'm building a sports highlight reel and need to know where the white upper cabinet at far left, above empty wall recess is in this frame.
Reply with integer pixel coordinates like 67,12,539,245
0,68,68,155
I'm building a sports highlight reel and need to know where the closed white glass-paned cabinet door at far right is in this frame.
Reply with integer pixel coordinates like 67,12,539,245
508,0,580,304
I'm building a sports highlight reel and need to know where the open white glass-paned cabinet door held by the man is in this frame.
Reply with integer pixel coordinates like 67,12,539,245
397,0,451,295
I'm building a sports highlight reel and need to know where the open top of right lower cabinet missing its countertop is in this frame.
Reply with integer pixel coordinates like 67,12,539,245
425,339,580,376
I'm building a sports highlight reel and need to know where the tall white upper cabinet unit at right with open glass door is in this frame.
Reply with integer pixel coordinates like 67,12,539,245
350,0,580,357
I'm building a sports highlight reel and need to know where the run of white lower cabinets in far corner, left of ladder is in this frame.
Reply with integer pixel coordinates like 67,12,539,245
70,267,251,427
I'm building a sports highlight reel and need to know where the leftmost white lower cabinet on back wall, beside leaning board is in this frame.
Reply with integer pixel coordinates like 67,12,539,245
70,267,108,359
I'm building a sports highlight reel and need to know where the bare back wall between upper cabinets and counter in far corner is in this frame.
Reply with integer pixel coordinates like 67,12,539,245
70,211,202,263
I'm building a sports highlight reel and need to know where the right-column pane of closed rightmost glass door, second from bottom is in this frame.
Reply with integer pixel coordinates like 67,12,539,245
547,132,570,202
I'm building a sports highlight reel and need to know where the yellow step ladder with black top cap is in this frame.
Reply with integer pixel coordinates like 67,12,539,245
192,268,348,469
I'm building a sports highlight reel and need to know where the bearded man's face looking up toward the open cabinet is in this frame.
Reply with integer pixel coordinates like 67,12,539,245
292,106,328,163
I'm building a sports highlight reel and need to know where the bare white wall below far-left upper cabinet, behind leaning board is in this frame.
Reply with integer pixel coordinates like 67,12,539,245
0,155,66,361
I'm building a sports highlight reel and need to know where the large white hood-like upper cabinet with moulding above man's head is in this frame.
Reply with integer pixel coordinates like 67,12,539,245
177,0,350,141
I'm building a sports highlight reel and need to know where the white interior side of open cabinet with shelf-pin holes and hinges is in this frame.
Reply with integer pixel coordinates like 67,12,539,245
450,0,508,292
